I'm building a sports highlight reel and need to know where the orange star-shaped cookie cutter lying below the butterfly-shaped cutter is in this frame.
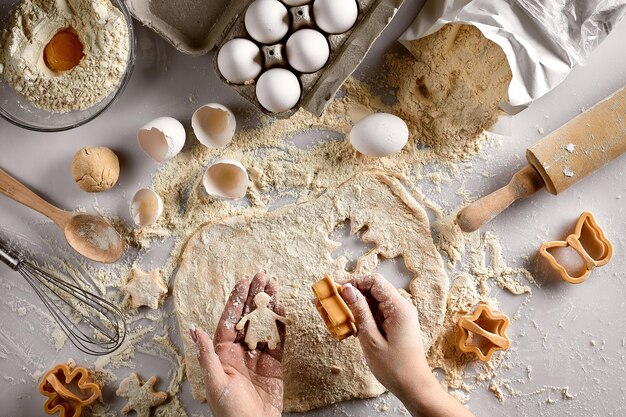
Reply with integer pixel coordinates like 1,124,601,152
456,302,511,362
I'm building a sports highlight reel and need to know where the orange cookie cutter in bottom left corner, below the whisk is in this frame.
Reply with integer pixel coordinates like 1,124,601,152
39,364,100,417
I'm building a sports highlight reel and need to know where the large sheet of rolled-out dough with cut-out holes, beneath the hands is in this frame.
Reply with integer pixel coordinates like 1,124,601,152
174,171,449,412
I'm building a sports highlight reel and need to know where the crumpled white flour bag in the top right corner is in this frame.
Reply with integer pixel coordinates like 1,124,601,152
400,0,626,111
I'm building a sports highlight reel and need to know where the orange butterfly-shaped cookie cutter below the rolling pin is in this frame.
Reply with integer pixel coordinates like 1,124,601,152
539,211,613,284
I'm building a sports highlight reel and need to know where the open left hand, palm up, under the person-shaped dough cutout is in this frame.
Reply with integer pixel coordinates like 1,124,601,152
190,272,285,417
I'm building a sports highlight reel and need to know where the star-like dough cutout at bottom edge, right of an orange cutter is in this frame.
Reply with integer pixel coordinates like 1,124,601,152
115,372,167,417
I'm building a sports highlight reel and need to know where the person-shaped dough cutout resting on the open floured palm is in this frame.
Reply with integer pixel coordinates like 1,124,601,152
235,292,291,350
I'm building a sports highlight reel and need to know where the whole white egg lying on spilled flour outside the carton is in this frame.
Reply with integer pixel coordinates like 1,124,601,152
350,113,409,157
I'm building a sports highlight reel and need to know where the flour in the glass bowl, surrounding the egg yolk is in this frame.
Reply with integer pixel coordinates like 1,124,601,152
0,0,130,113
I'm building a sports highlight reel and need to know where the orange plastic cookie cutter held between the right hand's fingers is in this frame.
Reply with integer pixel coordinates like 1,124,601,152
313,275,357,340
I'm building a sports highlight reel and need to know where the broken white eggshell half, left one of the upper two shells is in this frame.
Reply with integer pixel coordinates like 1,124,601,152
137,117,187,162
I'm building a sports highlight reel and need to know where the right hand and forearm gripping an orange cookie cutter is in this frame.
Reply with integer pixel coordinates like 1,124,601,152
341,274,472,417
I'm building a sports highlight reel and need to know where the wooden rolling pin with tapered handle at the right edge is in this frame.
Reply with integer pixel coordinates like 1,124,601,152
457,87,626,232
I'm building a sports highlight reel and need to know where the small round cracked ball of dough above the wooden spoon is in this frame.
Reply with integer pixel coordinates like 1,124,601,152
72,147,120,193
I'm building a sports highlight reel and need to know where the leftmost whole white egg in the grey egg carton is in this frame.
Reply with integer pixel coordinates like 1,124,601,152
217,38,263,84
